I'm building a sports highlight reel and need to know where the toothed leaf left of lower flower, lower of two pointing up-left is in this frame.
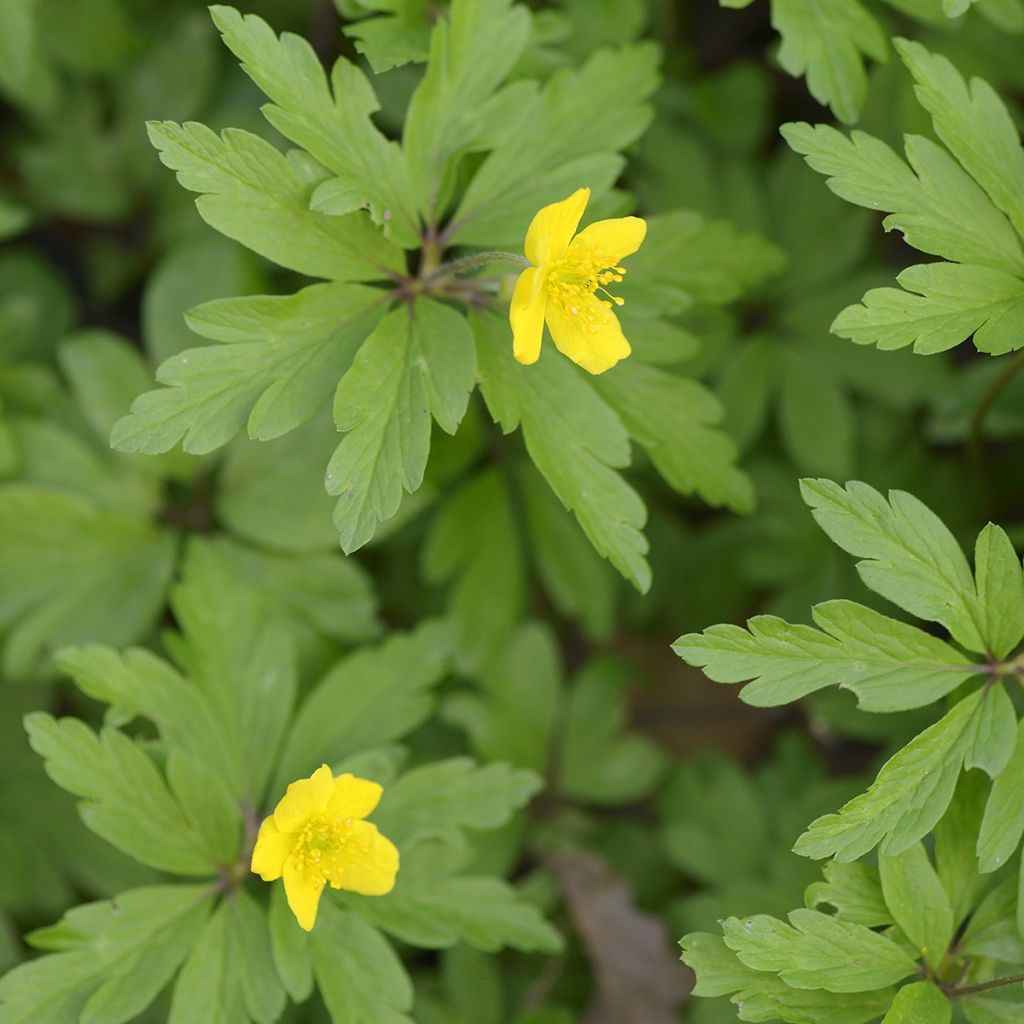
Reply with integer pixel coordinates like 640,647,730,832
25,712,216,876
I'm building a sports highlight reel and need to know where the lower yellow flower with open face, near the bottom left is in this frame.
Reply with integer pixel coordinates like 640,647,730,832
251,765,398,932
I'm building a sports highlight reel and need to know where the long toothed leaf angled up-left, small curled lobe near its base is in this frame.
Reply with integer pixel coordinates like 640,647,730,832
210,5,419,249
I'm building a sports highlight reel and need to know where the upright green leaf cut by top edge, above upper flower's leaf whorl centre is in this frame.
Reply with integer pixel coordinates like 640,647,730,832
402,0,529,224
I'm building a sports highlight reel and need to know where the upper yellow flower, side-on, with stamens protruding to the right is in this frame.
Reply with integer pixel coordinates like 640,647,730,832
509,188,647,374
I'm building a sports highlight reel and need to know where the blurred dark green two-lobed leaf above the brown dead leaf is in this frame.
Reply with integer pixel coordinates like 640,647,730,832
558,657,667,804
